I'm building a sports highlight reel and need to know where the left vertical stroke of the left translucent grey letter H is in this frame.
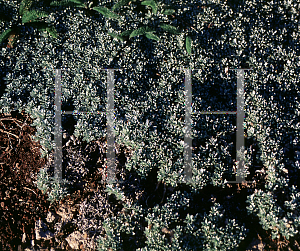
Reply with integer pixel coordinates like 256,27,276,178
54,69,62,179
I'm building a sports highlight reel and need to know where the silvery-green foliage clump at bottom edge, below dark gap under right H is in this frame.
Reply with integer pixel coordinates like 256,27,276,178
137,191,248,251
